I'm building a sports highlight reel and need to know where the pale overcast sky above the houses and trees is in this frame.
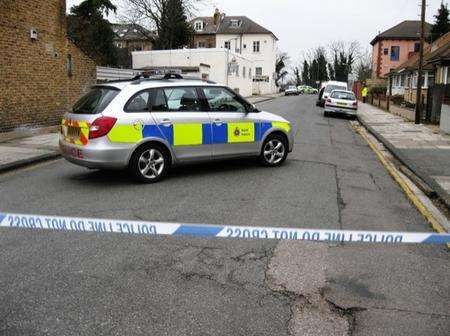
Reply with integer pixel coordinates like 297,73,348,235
67,0,447,62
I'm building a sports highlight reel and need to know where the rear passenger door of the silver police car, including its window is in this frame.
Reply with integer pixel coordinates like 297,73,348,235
151,87,212,161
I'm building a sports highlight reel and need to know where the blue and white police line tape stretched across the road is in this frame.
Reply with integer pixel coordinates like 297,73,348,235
0,213,450,244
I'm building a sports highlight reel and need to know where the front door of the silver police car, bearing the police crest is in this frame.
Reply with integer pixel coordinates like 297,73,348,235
202,87,259,158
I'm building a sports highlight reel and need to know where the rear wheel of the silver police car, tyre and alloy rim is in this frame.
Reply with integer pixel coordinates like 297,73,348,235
129,143,170,183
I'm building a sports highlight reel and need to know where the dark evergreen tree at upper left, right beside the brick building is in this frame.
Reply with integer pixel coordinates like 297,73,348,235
67,0,117,65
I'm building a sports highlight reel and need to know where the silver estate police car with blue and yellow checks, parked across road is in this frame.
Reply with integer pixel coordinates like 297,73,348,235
59,74,293,183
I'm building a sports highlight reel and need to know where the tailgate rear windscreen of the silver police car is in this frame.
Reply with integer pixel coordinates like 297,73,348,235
72,86,120,114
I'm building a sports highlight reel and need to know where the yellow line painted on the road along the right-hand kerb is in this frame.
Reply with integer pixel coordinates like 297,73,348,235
352,125,450,249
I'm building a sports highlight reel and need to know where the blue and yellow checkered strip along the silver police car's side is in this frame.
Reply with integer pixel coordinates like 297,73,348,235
108,122,291,146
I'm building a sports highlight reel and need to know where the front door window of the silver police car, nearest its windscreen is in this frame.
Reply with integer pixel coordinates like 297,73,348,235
203,87,246,112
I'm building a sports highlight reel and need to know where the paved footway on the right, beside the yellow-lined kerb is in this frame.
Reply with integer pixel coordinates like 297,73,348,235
358,103,450,209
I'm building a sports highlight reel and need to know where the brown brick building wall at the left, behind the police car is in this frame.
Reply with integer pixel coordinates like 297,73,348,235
0,0,95,132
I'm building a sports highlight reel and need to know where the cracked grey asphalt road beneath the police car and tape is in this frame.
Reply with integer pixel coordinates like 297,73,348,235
0,96,450,336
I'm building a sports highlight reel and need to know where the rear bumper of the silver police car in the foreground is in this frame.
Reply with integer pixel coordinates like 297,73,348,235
59,139,130,169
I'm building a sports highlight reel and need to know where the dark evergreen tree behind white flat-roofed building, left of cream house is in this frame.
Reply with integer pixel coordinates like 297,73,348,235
153,0,193,50
